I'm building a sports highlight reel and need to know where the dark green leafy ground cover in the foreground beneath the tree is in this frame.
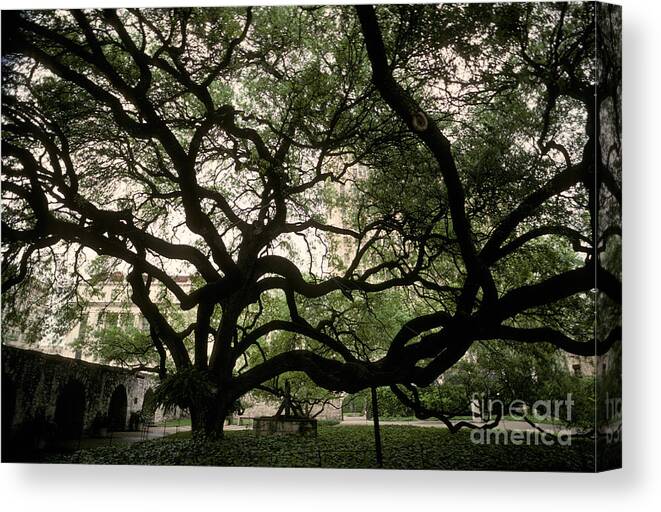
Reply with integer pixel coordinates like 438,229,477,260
51,426,594,471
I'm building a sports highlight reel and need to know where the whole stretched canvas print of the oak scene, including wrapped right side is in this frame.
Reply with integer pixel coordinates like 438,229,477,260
2,2,622,472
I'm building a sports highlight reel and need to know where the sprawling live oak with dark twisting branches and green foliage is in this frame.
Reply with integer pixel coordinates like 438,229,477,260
2,4,621,434
